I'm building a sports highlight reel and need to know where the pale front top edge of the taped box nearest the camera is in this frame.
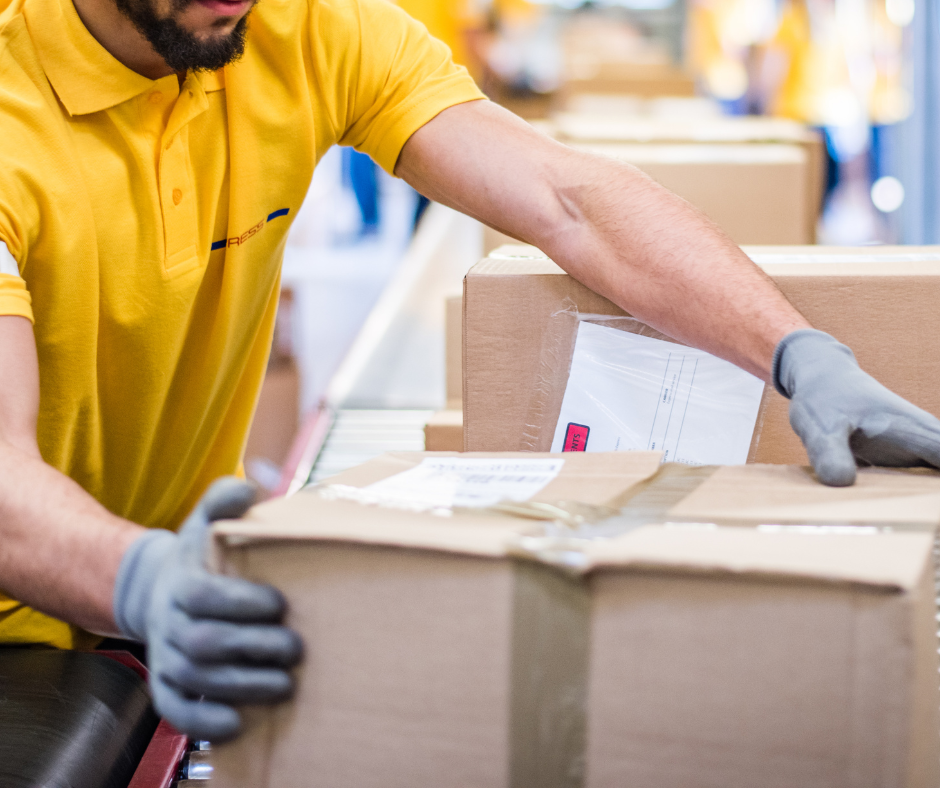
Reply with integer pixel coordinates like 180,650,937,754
213,510,932,591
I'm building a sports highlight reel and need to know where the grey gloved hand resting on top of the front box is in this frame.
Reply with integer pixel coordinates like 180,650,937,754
773,328,940,487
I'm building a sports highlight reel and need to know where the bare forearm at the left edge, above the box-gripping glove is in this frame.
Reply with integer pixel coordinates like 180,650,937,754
0,442,143,632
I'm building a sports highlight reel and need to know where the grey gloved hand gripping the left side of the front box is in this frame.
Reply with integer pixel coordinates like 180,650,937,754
114,478,302,741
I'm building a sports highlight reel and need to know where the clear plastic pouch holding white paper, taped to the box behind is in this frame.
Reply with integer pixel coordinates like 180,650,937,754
521,301,765,464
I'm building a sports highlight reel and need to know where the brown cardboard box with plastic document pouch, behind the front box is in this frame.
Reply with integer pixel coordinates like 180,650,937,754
464,246,940,464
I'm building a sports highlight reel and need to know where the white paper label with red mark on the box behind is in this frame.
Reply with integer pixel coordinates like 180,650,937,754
552,323,764,465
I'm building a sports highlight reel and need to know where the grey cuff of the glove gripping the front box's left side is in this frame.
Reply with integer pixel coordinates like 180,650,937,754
112,528,177,643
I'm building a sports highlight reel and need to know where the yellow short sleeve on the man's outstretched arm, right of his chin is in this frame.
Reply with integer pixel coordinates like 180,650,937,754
324,0,486,173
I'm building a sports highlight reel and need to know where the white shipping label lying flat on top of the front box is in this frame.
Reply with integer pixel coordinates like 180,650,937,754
362,457,565,510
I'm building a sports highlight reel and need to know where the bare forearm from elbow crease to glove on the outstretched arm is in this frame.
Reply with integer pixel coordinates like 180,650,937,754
535,151,809,379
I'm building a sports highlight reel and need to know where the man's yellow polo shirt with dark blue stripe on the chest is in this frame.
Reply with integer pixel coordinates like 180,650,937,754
0,0,482,647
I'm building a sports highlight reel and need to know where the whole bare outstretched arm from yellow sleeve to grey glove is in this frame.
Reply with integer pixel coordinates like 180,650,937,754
398,102,809,379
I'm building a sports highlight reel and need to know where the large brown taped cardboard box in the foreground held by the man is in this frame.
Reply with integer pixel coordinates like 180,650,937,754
213,452,940,788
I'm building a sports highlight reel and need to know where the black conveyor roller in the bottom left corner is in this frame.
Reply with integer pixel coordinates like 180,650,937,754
0,648,158,788
